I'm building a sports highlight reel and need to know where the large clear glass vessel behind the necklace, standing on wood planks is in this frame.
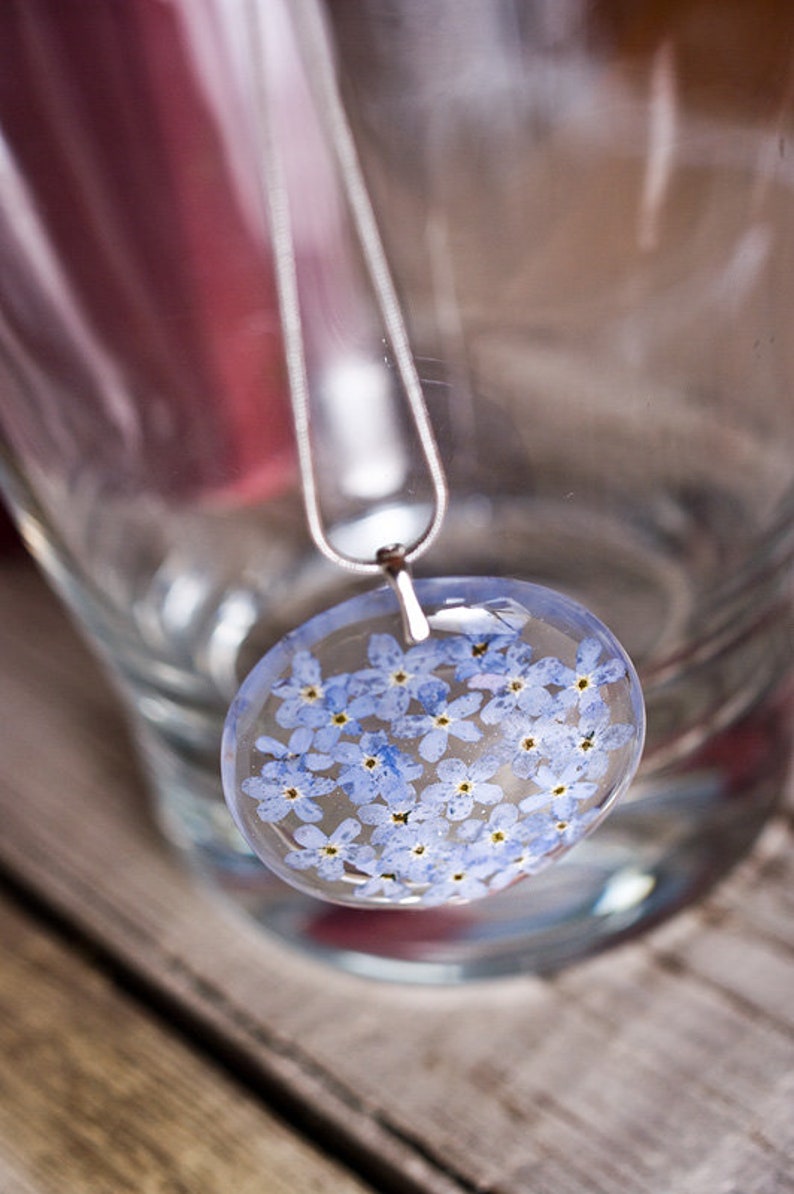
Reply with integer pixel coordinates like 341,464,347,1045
0,0,794,981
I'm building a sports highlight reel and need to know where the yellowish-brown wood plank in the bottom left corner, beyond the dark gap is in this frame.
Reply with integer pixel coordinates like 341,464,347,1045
0,900,367,1194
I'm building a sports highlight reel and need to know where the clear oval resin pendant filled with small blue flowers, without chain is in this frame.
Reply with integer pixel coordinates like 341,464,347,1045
222,577,645,909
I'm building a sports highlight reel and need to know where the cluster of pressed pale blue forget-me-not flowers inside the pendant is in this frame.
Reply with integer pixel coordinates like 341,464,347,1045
242,633,636,905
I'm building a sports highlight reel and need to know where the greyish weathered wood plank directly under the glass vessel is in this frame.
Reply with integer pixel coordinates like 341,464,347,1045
0,564,794,1194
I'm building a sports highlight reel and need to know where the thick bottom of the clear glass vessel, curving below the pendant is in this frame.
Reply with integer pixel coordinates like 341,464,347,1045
160,697,790,984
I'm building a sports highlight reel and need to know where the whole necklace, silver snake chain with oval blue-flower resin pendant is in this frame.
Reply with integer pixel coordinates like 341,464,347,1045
222,34,645,907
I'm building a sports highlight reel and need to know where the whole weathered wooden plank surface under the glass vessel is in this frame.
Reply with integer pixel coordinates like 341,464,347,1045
0,560,794,1194
